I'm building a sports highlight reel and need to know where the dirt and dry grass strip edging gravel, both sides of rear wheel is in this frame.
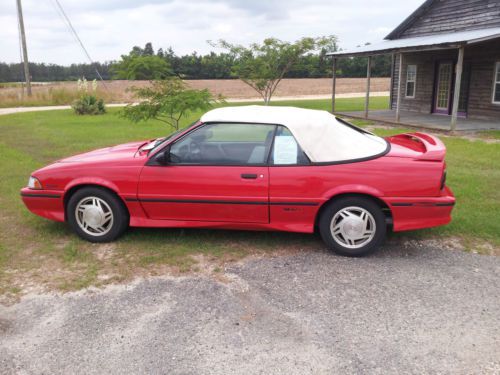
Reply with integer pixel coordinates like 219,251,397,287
0,235,500,308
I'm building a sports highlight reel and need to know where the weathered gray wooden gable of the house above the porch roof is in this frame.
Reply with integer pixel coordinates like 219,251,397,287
399,0,500,38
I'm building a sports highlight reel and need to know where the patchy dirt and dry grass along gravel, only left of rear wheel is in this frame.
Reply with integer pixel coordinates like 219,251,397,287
0,229,322,305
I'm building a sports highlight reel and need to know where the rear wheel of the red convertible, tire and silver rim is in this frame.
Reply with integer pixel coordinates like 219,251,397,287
319,197,387,256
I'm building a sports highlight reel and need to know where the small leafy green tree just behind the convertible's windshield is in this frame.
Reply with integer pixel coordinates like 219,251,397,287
121,77,222,130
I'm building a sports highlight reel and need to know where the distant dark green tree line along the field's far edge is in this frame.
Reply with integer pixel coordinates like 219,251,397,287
0,41,391,82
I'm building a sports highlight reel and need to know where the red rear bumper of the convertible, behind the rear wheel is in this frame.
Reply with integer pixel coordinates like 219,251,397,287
385,187,455,232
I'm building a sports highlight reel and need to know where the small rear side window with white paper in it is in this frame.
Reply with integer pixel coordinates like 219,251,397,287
270,126,310,165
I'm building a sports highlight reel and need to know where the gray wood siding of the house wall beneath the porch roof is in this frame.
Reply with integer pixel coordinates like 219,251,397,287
391,41,500,121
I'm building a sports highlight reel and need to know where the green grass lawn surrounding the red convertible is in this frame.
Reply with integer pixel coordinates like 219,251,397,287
0,98,500,296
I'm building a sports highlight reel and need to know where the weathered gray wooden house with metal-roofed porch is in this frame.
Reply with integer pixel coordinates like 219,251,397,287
331,0,500,130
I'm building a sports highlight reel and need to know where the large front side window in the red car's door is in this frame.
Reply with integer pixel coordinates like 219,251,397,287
170,123,276,165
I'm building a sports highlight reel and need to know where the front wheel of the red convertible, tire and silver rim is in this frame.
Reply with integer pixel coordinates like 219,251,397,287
66,187,129,242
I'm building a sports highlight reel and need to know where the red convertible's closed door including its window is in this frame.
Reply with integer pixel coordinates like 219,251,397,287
138,123,275,223
